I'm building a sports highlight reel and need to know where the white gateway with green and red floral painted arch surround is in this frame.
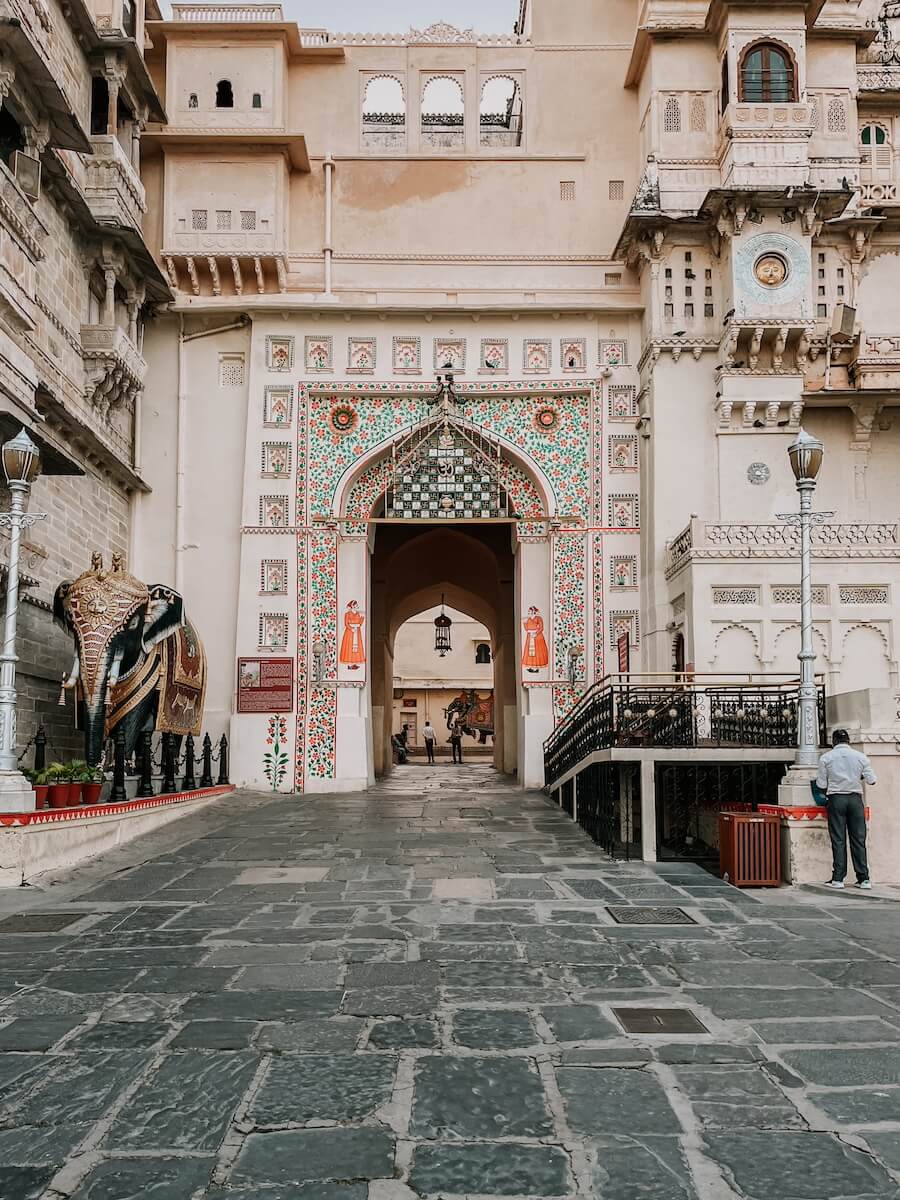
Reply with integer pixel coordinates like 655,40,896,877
232,357,638,792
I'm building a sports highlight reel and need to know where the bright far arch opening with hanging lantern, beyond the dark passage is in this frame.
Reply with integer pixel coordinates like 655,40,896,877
392,605,494,762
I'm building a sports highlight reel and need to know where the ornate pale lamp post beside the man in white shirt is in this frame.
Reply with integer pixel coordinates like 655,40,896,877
781,430,832,768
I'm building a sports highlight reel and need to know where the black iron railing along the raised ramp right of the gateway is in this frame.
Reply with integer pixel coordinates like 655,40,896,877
544,676,826,786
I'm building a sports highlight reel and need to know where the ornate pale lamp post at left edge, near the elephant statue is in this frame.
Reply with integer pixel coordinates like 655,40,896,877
0,430,46,812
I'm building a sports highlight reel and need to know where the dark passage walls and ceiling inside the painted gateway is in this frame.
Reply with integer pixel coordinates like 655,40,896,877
371,521,517,775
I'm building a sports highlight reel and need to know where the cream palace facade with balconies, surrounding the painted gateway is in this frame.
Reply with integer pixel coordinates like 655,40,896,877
4,0,900,806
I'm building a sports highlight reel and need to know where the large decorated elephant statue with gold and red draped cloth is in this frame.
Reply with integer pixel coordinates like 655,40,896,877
53,553,206,764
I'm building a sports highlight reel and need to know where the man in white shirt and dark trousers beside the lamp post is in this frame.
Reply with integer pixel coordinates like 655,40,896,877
816,730,877,890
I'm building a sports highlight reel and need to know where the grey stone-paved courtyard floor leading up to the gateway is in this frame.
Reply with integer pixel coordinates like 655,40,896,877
0,766,900,1200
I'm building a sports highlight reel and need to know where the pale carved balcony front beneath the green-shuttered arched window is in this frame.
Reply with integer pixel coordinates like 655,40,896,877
719,103,812,190
